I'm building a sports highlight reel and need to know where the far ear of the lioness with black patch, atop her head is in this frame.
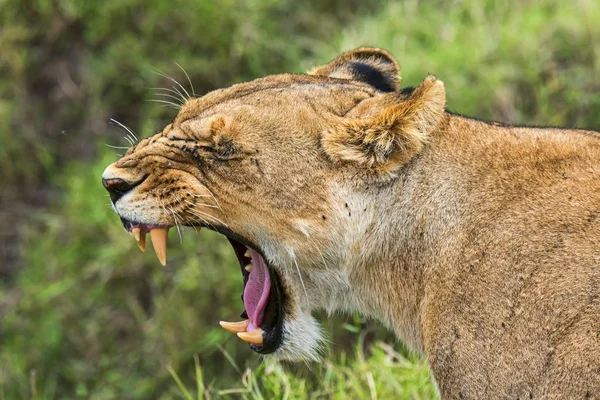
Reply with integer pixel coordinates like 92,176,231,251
308,47,400,92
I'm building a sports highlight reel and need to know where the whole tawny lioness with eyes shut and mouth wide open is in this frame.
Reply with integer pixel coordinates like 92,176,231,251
102,48,600,399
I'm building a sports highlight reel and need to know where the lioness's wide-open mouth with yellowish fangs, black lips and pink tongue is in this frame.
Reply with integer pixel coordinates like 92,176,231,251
121,218,285,354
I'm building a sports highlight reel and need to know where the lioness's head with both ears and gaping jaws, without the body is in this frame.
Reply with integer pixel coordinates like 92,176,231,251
103,48,445,359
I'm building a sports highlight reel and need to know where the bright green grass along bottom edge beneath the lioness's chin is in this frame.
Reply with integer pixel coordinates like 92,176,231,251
169,342,437,400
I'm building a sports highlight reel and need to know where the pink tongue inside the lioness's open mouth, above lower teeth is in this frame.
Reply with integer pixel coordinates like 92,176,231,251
244,250,271,331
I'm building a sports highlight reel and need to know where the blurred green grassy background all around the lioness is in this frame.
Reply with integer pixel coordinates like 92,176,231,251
0,0,600,400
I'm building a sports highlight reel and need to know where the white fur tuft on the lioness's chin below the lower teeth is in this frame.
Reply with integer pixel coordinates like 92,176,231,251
271,314,325,361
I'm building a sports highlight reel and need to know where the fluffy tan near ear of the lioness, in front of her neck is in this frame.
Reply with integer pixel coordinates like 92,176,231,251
321,75,446,175
